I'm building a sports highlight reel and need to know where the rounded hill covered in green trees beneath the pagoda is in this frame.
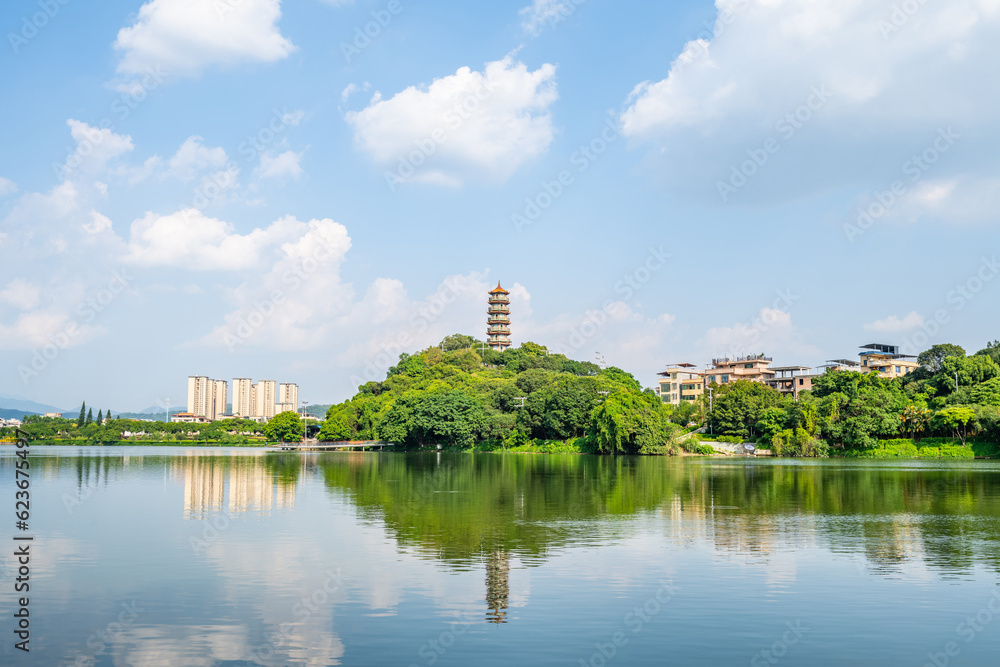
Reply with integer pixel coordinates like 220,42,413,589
320,334,677,454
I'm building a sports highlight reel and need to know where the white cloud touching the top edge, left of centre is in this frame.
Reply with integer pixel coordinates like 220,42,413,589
114,0,296,75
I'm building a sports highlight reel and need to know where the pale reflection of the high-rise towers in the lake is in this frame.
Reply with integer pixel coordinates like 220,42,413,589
175,456,297,519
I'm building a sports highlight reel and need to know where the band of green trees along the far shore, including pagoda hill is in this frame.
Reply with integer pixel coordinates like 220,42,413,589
0,334,1000,459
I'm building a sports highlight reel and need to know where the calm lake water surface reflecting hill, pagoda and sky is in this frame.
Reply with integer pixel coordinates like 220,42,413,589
0,447,1000,667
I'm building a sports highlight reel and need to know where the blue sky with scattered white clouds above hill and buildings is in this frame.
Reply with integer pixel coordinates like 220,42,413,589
0,0,1000,411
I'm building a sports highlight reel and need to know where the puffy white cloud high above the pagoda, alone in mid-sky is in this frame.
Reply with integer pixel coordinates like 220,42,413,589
346,57,558,185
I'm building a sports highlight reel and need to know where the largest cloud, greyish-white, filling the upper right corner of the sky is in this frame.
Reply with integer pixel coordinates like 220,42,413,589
621,0,1000,202
